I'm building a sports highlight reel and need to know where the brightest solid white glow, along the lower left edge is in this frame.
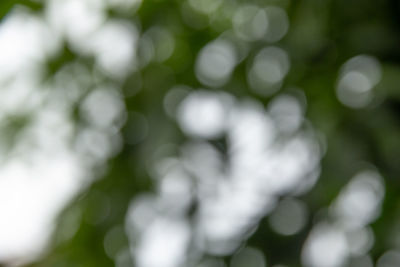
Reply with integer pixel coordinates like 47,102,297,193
0,107,85,261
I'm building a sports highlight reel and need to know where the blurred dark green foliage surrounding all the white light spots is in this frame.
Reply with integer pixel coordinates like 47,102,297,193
0,0,400,267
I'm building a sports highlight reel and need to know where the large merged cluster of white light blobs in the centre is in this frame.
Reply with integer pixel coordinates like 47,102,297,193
127,91,322,262
